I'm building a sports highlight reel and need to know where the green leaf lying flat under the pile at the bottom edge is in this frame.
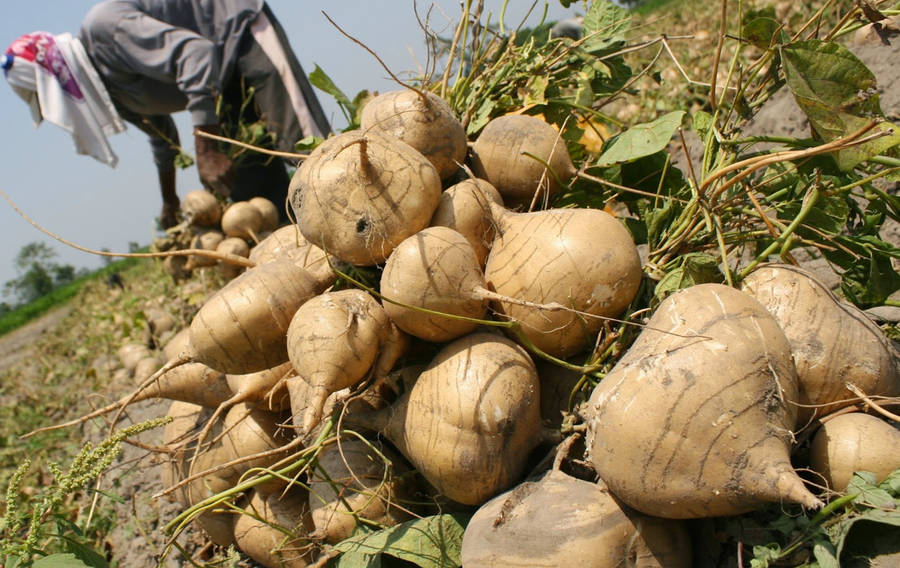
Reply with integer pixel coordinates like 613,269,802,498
334,514,468,568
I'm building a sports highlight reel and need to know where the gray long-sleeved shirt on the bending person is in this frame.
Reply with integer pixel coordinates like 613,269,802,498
80,0,264,166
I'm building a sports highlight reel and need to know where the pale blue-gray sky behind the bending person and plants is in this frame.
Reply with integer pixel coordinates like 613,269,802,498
0,0,583,292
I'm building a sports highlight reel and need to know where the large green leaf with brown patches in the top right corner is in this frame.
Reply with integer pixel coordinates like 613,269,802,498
780,40,900,171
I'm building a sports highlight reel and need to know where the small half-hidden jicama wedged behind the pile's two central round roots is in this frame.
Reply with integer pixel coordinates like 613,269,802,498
429,178,503,267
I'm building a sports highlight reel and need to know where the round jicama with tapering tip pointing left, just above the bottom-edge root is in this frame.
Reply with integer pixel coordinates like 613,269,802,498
345,333,541,505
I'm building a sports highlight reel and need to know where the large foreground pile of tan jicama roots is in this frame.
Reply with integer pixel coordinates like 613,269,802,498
74,89,900,568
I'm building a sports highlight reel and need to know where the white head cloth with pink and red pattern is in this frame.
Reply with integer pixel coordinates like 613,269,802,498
5,32,125,167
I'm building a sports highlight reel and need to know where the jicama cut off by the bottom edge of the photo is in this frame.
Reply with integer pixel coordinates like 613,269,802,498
461,470,692,568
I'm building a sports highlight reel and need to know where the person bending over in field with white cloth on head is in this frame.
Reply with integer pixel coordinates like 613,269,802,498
0,0,330,227
